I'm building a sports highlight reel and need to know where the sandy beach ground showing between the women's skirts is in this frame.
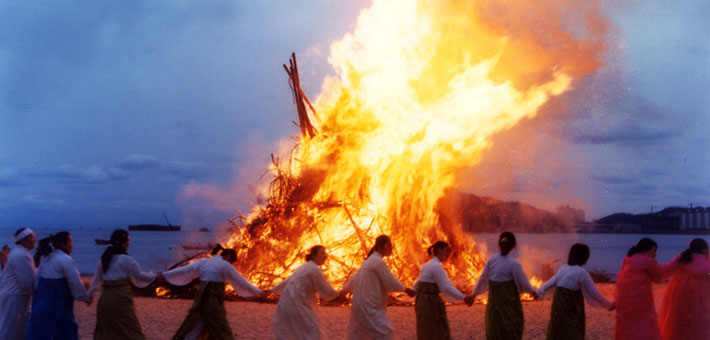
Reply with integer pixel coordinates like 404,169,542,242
74,284,665,340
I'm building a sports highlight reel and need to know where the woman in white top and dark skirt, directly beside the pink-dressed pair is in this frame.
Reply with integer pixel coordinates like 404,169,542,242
537,243,614,340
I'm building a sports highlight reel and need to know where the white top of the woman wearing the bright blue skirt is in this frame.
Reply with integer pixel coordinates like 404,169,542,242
37,249,90,301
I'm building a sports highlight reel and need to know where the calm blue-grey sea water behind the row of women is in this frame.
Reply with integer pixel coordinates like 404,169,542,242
0,229,710,280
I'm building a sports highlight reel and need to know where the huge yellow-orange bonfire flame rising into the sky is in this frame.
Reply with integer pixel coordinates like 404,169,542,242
221,0,603,287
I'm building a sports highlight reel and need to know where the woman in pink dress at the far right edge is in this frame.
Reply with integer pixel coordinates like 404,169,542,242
658,238,710,340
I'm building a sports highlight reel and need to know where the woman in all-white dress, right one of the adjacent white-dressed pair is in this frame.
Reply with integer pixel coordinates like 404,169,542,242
341,235,415,340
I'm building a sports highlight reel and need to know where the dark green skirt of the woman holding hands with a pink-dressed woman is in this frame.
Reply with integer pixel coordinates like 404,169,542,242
547,287,585,340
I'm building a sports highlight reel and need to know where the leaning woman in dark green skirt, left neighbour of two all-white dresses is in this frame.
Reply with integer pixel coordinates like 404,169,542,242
163,247,263,340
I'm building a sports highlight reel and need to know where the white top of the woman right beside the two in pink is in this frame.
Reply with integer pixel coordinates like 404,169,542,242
537,265,611,309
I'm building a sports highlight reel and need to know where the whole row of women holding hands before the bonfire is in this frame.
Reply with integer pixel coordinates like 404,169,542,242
0,228,710,339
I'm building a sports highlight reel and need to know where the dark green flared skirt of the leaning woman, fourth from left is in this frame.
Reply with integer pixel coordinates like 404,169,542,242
172,281,234,340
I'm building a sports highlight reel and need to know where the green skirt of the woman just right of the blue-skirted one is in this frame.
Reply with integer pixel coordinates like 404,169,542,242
94,278,145,340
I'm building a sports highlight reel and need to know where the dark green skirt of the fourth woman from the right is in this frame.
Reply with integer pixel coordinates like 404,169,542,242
486,281,525,340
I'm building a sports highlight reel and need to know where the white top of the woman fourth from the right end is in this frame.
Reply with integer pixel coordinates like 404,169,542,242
473,253,535,295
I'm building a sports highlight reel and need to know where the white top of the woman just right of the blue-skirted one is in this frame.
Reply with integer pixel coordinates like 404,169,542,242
89,254,156,295
